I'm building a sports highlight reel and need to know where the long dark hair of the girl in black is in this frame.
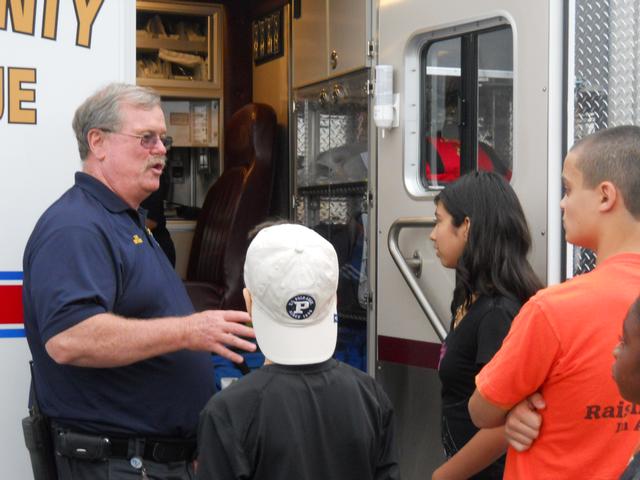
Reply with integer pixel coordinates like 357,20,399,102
435,172,543,317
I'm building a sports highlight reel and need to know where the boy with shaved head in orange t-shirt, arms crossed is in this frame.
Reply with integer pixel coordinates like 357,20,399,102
469,127,640,480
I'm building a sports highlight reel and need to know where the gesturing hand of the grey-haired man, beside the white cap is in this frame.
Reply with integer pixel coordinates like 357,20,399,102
186,310,256,363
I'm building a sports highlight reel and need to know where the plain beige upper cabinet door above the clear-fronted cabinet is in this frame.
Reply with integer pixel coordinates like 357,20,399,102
293,0,371,88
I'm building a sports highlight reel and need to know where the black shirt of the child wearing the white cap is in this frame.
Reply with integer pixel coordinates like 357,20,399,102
197,359,400,480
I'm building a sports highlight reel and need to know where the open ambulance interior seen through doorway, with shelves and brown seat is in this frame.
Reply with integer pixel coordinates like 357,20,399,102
136,0,371,378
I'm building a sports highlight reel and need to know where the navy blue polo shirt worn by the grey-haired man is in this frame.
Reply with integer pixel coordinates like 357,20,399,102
23,172,215,437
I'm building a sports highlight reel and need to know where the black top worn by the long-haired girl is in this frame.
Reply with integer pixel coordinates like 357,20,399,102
438,296,521,480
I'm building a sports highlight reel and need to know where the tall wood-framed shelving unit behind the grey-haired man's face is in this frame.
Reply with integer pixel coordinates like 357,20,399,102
136,0,224,214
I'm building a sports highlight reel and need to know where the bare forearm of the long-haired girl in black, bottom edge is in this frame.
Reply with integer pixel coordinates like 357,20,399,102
431,427,507,480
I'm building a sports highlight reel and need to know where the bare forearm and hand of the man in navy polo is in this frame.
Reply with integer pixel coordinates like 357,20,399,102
45,310,256,368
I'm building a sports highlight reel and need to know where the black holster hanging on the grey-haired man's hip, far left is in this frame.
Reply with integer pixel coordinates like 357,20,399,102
22,409,58,480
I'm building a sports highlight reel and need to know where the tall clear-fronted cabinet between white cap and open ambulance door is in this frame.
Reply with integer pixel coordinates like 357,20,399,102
292,69,370,370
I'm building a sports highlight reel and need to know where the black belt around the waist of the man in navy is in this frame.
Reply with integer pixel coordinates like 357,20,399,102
54,428,196,463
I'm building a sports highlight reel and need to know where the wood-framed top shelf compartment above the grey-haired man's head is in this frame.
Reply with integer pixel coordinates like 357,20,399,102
136,0,223,98
